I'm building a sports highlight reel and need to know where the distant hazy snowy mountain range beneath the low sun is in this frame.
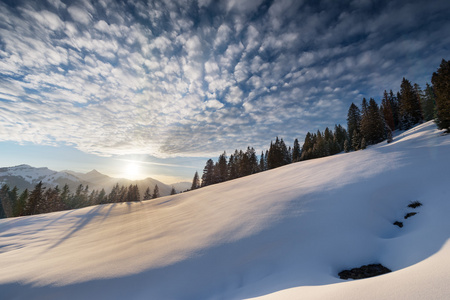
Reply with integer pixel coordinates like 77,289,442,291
0,165,190,197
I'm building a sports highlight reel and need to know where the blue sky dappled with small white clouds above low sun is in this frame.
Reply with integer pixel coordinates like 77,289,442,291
0,0,450,183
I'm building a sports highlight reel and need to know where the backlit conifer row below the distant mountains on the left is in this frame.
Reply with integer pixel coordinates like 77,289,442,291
0,182,176,218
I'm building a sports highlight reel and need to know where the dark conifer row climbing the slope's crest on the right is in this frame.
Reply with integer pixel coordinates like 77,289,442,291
191,59,450,190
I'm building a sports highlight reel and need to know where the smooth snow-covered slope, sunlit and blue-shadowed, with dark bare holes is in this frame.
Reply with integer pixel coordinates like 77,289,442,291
0,122,450,299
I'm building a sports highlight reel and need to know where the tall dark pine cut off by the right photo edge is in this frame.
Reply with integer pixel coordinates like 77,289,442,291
431,59,450,132
